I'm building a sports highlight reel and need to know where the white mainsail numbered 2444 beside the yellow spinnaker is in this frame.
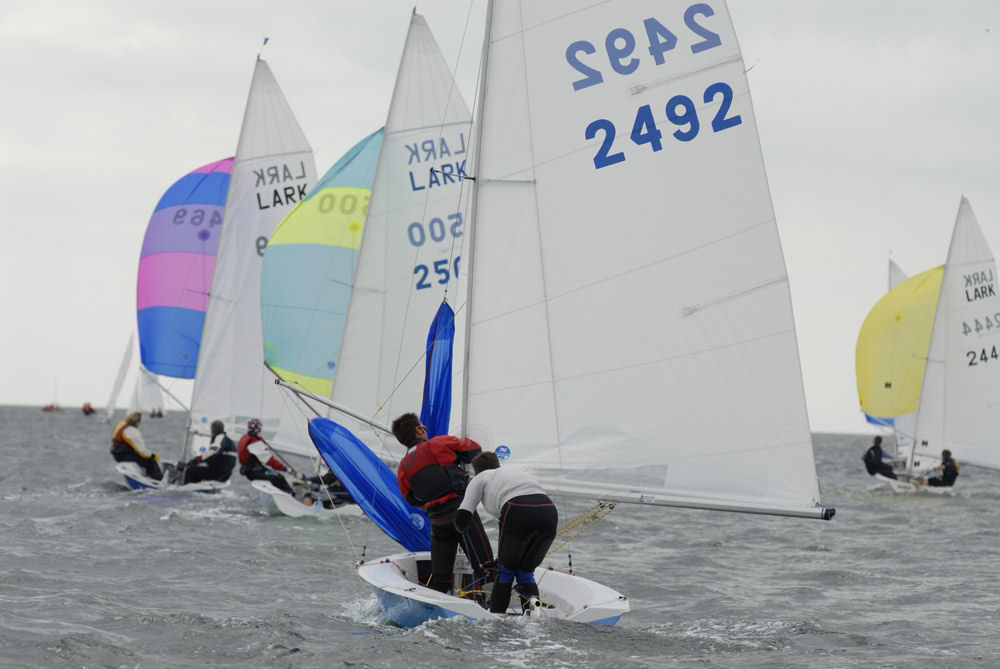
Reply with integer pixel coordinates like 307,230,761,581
916,197,1000,468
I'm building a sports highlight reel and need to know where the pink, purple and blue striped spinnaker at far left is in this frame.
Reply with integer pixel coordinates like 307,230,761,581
136,158,233,379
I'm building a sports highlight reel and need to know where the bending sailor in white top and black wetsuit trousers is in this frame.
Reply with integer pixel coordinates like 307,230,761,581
455,467,559,613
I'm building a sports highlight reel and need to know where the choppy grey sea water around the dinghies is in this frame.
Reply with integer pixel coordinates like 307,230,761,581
0,407,1000,669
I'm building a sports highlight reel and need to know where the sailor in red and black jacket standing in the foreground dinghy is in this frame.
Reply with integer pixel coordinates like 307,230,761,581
392,413,493,592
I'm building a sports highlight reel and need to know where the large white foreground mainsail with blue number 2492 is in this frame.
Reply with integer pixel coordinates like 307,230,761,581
465,1,829,518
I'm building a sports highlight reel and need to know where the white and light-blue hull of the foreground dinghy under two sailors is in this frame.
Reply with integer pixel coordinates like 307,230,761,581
358,552,629,627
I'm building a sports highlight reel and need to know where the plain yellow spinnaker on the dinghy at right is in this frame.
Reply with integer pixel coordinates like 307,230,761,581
854,265,944,418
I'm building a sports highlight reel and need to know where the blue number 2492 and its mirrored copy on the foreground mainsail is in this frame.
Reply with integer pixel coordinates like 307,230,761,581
566,3,743,169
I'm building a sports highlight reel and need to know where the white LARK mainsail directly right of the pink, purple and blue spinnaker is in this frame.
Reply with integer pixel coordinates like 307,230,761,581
189,58,316,454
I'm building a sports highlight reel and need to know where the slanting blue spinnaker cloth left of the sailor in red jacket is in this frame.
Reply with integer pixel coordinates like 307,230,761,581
309,418,431,552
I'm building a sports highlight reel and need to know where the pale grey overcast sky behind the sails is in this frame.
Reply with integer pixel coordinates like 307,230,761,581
0,0,1000,432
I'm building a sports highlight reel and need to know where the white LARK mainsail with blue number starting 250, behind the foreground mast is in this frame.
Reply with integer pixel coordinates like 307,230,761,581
333,13,470,456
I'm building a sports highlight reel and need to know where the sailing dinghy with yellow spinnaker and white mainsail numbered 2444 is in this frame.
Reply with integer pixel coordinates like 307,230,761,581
858,197,1000,494
